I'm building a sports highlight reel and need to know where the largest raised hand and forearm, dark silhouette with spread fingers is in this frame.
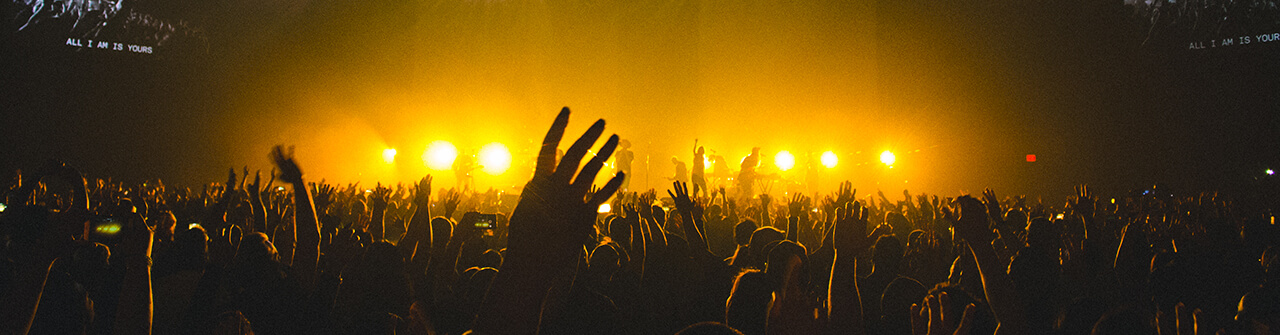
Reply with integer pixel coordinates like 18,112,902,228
475,107,625,334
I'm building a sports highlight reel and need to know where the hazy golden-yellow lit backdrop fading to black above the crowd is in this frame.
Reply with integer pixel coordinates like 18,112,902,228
0,0,1280,198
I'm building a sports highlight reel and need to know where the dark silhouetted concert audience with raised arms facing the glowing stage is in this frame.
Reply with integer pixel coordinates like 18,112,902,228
0,107,1280,335
